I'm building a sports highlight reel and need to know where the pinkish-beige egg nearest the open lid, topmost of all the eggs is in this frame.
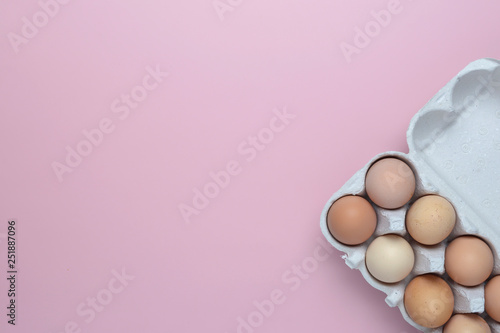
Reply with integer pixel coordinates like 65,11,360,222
365,157,415,209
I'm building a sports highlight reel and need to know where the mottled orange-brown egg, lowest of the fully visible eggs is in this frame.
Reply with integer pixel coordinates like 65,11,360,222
404,274,455,328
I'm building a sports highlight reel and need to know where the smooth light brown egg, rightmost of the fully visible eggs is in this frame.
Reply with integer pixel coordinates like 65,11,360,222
444,236,493,287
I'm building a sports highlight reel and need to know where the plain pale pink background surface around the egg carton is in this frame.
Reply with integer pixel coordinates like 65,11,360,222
0,0,500,333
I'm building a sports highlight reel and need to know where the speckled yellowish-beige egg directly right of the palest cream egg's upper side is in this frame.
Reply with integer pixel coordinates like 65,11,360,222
406,195,456,245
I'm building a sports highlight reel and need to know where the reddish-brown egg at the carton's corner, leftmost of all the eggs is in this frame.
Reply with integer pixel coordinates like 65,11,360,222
327,195,377,245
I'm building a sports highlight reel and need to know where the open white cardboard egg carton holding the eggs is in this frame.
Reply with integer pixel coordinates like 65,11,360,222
320,59,500,333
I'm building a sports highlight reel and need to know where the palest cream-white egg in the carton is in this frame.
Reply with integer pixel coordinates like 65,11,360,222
365,235,415,283
